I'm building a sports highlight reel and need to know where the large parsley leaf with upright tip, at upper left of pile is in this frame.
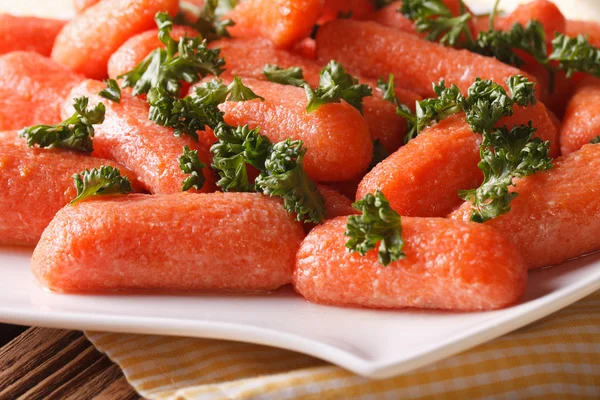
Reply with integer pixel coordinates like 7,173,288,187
118,13,225,96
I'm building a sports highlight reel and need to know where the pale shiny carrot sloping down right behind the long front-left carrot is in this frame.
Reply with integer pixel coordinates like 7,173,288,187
63,80,215,193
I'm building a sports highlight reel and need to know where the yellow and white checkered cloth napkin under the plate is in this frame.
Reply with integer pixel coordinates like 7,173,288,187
87,292,600,400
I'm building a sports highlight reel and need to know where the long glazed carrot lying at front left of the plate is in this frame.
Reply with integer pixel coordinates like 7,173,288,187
31,193,304,292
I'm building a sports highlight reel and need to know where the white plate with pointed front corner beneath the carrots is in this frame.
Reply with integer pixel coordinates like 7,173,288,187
0,248,600,378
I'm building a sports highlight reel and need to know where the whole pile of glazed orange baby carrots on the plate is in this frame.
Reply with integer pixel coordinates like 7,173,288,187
0,0,600,311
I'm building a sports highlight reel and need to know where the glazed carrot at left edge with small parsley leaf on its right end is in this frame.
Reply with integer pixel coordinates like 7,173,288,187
0,131,139,246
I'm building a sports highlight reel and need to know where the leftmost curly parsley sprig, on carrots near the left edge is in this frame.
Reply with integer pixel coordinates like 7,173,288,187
19,97,106,153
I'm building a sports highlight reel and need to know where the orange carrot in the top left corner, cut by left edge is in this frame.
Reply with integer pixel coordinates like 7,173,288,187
0,14,67,56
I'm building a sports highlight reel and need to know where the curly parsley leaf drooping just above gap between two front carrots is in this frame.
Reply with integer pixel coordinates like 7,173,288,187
255,139,325,224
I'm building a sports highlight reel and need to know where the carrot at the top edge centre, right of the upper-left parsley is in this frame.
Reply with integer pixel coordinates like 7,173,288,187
225,0,323,47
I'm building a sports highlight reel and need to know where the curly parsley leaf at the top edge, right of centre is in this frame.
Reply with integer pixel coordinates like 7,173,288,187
398,0,473,47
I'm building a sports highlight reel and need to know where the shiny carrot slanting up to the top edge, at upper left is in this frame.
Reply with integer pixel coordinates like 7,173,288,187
52,0,178,79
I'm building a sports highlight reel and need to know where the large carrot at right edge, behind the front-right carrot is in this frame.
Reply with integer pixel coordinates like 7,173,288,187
450,145,600,268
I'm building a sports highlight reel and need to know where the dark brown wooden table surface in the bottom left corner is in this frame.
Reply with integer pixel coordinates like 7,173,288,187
0,324,140,400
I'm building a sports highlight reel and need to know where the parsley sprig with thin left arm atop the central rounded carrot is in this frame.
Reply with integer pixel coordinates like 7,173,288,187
263,60,372,113
